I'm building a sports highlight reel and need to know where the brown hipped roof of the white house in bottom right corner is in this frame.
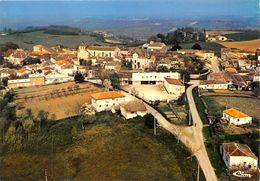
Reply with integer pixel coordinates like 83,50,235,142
223,143,258,160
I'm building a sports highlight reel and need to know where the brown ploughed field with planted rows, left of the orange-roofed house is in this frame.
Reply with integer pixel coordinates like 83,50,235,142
15,82,101,120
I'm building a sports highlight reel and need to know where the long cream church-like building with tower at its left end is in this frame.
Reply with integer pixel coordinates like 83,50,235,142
77,45,121,60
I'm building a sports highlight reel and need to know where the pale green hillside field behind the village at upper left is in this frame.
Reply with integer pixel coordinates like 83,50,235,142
0,31,107,49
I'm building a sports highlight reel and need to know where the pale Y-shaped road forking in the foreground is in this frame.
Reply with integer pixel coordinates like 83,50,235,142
124,85,217,181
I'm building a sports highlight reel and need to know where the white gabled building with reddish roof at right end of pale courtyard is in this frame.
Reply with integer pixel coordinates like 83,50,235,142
163,78,185,96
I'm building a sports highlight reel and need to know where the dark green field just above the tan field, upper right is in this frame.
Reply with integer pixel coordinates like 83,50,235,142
225,30,260,41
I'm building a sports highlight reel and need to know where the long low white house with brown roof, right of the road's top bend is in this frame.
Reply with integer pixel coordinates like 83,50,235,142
198,80,228,90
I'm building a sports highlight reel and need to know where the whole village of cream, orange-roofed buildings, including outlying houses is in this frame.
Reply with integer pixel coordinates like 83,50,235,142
0,34,260,177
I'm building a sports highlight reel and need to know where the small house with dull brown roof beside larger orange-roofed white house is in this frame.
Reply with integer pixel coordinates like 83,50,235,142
120,100,147,119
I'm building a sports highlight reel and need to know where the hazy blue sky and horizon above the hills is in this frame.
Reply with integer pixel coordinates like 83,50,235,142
0,0,259,29
